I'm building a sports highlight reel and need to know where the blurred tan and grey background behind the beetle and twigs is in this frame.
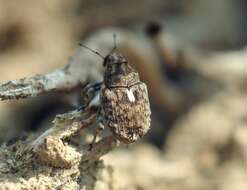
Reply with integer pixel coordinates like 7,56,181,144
0,0,247,190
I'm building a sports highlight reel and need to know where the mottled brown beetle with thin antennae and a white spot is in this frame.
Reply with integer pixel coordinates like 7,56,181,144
80,35,151,144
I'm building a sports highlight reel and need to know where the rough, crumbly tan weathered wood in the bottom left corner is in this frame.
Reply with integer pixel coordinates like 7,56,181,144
0,107,119,190
